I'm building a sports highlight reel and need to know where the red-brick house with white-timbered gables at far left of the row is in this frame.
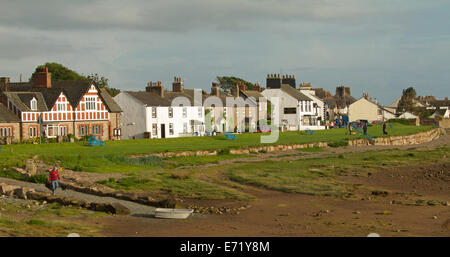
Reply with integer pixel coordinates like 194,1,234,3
0,68,122,140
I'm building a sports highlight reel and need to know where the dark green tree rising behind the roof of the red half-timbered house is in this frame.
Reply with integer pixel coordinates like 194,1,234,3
36,62,120,97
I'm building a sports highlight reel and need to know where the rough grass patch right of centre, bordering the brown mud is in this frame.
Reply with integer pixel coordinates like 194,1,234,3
223,147,449,196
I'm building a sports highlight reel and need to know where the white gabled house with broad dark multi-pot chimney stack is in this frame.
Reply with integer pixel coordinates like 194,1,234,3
262,75,325,131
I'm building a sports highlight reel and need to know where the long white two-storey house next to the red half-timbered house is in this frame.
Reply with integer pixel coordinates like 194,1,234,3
114,77,205,139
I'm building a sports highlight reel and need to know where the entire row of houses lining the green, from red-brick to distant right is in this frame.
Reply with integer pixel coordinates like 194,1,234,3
0,67,450,143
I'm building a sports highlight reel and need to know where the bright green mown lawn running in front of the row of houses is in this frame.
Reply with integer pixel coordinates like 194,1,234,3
0,124,431,173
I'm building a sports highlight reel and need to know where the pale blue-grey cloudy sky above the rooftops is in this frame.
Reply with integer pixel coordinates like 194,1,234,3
0,0,450,105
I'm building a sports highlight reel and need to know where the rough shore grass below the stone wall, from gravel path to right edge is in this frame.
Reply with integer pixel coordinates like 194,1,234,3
96,146,450,201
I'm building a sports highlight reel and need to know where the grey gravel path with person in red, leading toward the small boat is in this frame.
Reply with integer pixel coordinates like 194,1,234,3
0,177,156,217
